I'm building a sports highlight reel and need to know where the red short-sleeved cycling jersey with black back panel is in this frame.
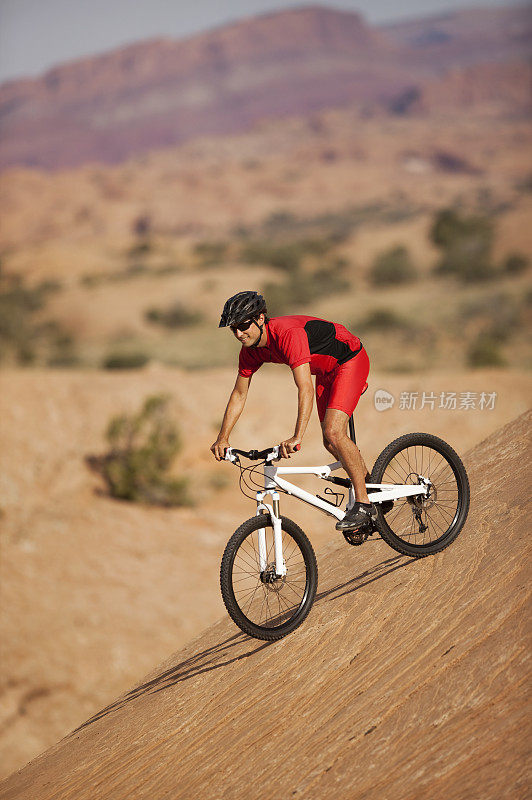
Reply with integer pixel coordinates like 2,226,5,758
238,315,362,378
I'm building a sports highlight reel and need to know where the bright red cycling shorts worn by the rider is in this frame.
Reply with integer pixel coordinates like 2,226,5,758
316,348,369,422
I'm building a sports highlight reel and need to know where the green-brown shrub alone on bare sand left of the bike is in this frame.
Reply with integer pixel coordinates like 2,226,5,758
87,395,190,506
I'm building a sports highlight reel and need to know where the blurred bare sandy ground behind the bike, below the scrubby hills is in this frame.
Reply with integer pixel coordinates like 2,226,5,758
0,364,531,775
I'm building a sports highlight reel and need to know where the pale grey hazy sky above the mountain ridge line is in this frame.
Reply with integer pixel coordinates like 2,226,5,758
0,0,524,82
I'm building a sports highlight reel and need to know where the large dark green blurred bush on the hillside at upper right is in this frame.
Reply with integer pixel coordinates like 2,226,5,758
430,208,496,283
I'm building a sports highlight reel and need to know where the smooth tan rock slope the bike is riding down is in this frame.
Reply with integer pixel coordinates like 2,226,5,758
0,412,532,800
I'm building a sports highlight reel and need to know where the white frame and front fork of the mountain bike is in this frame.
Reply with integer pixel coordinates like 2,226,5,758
225,447,430,576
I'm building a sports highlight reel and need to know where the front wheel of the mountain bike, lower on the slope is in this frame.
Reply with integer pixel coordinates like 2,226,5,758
220,514,318,641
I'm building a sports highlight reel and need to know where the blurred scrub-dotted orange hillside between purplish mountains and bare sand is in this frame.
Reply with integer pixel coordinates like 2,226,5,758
0,103,532,372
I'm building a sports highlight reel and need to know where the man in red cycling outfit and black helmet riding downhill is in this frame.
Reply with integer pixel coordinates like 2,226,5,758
211,291,377,530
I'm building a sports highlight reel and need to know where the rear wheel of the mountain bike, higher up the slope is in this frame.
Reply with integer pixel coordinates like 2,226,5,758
371,433,469,558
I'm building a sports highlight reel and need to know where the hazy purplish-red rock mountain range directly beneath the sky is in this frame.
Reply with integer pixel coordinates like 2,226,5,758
0,6,530,169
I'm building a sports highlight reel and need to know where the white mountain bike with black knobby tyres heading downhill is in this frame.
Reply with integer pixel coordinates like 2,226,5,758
220,428,469,641
